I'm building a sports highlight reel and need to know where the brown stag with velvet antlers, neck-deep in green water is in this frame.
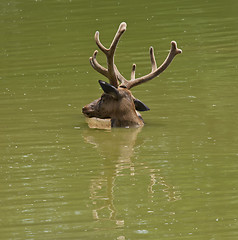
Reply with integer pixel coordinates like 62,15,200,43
82,22,182,127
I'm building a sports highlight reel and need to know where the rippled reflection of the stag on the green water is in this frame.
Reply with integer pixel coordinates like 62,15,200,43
83,128,180,233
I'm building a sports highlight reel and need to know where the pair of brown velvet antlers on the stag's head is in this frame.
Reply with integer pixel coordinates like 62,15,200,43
90,22,182,89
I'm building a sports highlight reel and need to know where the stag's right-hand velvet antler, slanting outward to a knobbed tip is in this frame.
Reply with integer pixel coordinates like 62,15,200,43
126,41,182,89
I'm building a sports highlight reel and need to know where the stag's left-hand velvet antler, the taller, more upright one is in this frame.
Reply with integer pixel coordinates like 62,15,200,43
89,22,127,87
